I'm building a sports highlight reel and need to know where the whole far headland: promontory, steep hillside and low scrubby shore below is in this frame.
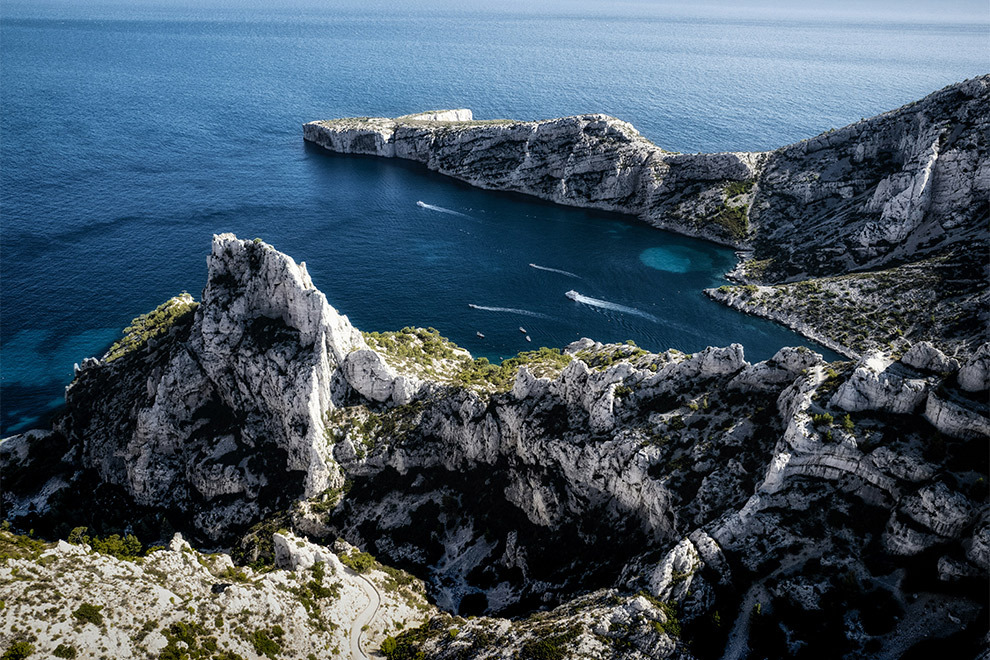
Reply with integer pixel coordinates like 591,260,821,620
303,81,990,366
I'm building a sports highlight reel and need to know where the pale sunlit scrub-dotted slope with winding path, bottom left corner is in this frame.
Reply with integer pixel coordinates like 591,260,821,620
0,531,437,659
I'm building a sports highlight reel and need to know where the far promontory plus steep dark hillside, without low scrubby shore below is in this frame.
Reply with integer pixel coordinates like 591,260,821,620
303,76,990,282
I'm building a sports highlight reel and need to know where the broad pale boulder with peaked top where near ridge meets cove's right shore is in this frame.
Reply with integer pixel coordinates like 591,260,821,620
829,353,928,414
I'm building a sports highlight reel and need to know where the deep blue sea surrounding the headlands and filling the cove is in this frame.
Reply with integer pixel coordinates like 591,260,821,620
0,2,988,433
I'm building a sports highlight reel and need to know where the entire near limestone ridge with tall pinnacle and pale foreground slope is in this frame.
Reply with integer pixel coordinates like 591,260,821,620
0,231,990,660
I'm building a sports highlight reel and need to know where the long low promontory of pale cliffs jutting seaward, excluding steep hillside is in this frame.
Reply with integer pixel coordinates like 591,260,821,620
303,111,765,245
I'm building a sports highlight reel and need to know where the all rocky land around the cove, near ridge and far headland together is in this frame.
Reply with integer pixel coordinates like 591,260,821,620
0,76,990,660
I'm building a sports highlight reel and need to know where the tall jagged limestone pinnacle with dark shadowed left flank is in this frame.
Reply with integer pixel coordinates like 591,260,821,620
51,234,380,536
